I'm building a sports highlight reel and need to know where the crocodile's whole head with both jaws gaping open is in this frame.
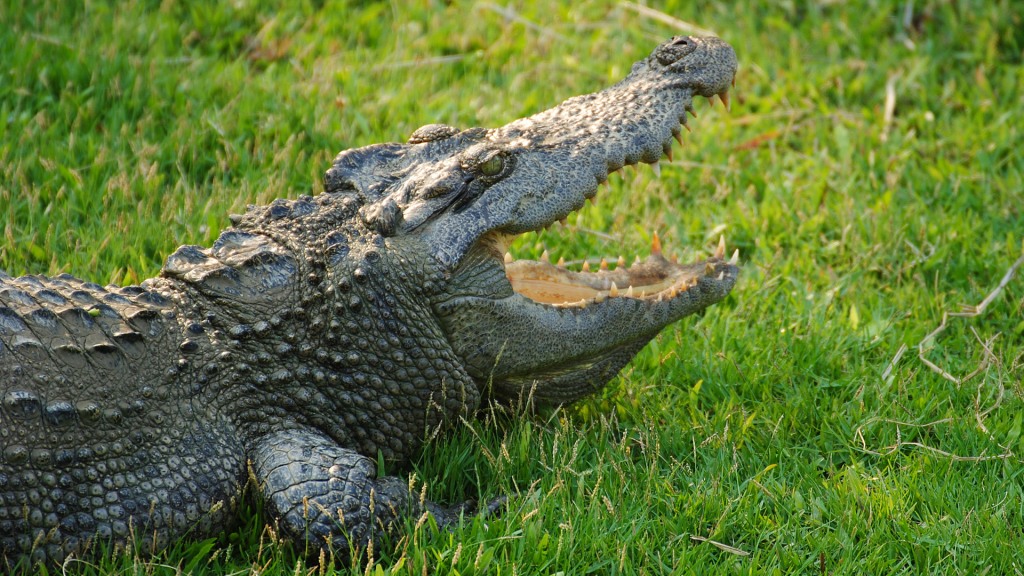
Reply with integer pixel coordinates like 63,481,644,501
325,37,738,404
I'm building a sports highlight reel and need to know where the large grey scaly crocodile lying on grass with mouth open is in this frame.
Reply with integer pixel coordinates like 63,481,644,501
0,36,739,569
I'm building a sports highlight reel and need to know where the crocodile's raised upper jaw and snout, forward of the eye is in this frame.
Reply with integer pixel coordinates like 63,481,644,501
428,37,736,270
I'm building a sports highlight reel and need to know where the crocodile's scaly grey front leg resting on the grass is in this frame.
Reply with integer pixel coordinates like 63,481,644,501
251,429,465,556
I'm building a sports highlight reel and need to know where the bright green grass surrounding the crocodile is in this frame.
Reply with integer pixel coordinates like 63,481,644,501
0,0,1024,575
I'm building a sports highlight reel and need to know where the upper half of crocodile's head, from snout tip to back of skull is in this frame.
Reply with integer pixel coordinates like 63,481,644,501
325,37,736,274
